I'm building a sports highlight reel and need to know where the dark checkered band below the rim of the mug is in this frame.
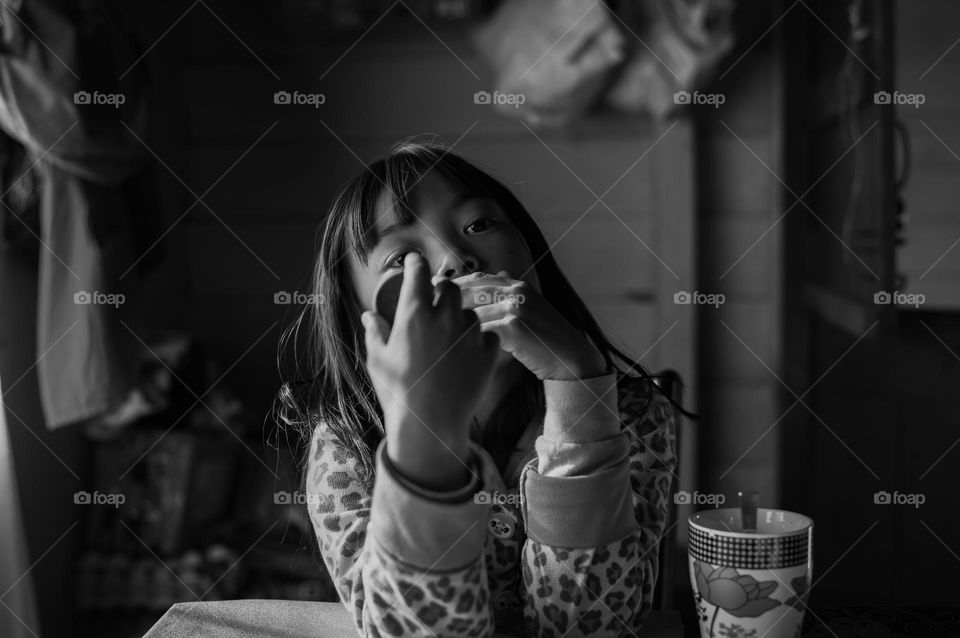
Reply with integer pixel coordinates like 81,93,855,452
689,525,811,569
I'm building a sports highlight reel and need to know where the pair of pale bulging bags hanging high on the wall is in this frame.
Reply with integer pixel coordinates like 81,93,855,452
476,0,736,127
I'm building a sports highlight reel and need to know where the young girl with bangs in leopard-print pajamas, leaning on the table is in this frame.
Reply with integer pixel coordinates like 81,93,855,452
278,142,677,638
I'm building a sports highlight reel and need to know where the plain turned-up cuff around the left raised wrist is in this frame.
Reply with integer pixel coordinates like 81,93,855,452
370,440,491,572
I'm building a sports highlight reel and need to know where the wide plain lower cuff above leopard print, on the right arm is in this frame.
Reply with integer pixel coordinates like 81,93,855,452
520,460,638,548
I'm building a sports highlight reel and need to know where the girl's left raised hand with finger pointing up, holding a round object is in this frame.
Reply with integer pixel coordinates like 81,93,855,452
361,252,499,480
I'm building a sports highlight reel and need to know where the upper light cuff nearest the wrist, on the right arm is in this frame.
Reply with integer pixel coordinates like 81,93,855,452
543,372,620,443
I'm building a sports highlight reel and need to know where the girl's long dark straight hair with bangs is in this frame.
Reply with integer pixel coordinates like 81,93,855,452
274,141,679,484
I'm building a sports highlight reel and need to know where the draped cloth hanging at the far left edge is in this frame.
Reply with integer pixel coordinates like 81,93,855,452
0,0,159,428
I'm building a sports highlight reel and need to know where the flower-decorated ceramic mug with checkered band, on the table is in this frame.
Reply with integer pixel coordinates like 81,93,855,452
688,508,813,638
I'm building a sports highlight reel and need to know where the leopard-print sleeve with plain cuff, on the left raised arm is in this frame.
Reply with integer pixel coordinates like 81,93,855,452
306,427,502,637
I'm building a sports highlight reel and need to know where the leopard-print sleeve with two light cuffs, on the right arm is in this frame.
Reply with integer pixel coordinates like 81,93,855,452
520,373,677,638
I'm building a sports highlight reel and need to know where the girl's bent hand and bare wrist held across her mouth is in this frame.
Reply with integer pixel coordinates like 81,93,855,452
454,270,607,380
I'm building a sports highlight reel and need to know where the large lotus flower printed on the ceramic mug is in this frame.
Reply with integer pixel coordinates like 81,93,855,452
693,560,781,618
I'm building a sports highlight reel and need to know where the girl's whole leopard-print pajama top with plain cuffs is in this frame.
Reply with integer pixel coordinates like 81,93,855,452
306,371,677,638
